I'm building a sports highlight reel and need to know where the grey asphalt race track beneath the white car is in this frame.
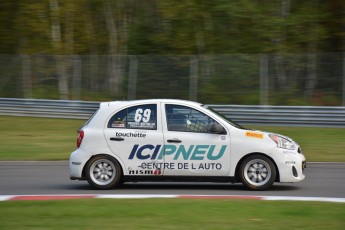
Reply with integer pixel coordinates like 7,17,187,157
0,161,345,198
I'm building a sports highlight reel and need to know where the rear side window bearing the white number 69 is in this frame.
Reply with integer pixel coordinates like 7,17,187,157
108,104,157,130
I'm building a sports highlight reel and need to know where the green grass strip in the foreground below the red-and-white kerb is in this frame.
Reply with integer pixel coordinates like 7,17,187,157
0,199,345,230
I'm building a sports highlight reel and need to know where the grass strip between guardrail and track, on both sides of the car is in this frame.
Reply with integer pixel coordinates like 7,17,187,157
0,116,345,162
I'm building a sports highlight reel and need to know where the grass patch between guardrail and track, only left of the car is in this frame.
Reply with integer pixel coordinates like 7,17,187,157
0,116,85,160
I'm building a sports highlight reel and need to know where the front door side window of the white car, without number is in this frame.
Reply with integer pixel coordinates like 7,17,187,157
165,105,218,133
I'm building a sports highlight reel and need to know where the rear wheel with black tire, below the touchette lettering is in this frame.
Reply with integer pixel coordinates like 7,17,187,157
85,155,122,189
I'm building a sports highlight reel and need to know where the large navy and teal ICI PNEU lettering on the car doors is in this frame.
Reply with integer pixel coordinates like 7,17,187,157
128,145,227,161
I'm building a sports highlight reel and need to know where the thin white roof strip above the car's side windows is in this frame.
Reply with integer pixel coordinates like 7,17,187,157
100,99,201,107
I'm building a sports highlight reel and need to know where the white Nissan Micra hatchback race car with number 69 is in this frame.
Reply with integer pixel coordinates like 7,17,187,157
69,99,305,190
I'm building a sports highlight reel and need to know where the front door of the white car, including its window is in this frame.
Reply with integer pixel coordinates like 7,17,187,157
161,103,230,176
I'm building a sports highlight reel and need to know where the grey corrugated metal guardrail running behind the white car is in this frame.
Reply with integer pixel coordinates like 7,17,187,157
0,98,345,128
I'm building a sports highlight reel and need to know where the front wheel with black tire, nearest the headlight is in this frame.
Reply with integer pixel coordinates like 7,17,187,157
240,154,277,191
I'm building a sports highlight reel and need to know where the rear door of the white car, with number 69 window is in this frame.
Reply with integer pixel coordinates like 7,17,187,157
104,104,164,176
